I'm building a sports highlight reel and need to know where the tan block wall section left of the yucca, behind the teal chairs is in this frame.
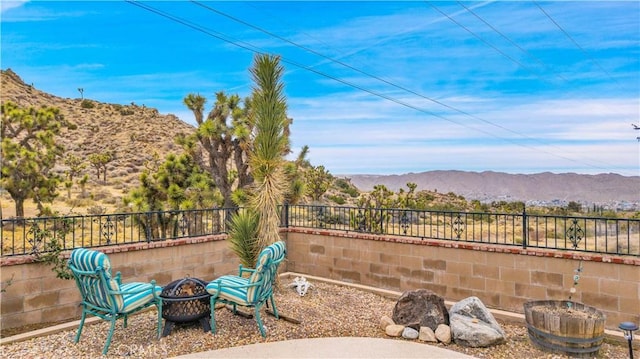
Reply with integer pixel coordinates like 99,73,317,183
0,236,239,328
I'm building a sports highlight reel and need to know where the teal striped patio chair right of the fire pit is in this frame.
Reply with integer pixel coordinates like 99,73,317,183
206,241,286,337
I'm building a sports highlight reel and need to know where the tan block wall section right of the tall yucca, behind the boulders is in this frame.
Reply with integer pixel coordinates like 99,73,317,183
285,228,640,329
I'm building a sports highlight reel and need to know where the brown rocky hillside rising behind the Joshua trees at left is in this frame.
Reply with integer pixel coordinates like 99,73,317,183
0,69,195,188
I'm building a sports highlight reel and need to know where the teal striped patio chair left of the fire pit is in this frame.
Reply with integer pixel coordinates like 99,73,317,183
67,248,162,355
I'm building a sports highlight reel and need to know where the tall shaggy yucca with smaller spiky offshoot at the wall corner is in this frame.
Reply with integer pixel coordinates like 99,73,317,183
229,55,290,268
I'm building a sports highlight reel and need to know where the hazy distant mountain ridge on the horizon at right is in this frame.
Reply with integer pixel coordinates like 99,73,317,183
347,171,640,203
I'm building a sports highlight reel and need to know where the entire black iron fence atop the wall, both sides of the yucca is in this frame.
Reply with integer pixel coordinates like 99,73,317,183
0,205,640,257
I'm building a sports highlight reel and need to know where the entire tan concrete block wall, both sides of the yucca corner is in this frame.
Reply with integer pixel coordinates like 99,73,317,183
0,228,640,329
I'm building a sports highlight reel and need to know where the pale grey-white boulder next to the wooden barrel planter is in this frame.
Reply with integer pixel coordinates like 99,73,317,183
450,297,505,348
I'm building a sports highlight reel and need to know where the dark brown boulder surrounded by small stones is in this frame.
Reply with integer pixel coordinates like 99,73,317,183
392,289,449,331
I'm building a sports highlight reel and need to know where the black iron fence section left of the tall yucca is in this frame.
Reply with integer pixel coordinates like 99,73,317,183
0,208,233,256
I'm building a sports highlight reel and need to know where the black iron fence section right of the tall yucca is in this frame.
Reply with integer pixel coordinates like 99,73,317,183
285,205,640,256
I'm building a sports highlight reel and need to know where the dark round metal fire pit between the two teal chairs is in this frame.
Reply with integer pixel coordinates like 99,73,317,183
160,277,211,337
